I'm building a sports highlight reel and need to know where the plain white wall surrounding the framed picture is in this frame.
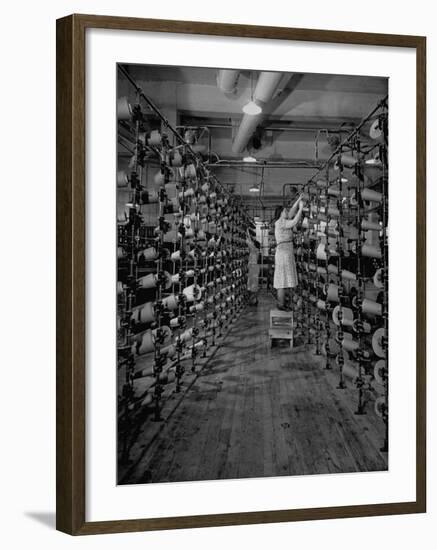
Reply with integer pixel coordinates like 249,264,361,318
0,0,437,550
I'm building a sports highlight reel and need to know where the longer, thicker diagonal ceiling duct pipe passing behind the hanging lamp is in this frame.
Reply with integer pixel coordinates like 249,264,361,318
232,72,282,154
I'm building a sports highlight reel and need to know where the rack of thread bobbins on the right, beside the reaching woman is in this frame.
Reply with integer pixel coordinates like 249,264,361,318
293,99,388,451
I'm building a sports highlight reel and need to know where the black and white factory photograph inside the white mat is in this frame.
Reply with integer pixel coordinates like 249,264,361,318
116,63,388,485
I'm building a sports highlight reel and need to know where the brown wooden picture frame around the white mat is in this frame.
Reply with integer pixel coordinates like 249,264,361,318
56,15,426,535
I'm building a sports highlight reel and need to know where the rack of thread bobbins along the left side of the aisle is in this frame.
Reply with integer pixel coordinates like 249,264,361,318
117,69,252,466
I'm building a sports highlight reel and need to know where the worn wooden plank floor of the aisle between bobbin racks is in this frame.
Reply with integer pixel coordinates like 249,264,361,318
123,295,388,483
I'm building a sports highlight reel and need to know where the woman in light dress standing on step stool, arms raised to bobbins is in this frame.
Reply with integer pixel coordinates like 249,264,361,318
273,196,303,311
